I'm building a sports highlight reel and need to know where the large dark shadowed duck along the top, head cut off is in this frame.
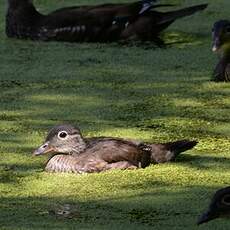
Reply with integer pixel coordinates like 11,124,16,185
5,0,207,42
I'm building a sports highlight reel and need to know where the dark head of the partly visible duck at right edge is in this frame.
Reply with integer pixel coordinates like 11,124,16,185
212,20,230,52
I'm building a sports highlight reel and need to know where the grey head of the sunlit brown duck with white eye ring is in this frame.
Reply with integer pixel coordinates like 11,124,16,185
33,125,86,155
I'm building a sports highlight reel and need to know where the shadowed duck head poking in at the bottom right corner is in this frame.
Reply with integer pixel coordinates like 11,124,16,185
197,186,230,225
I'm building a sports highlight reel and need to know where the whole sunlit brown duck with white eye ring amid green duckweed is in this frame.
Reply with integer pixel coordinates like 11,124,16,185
33,124,197,174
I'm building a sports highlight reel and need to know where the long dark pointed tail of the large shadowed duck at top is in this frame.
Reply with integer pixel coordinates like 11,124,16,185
159,4,208,24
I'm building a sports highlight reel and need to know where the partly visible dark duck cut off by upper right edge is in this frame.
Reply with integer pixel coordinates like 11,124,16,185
212,20,230,82
